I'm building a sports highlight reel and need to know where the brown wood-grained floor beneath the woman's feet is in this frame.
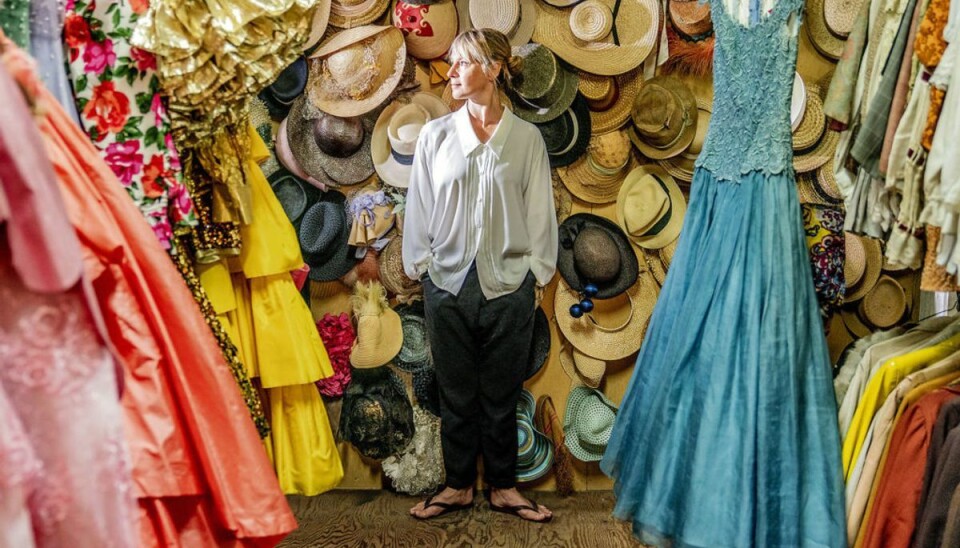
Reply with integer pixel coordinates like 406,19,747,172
280,491,642,548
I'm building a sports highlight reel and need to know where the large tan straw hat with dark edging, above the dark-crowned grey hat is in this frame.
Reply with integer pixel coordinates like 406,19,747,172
307,25,407,117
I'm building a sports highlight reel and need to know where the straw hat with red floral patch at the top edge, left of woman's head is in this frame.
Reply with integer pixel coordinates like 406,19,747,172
393,0,457,61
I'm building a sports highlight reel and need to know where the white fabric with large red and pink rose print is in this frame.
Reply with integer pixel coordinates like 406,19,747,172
63,0,196,249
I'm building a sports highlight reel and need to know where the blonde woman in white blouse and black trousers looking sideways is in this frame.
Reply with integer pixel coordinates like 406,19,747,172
403,29,557,522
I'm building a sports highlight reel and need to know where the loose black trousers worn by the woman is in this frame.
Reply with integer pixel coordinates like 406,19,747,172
423,266,536,489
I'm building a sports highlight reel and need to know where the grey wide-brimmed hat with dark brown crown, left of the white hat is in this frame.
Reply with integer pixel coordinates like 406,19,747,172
286,96,377,185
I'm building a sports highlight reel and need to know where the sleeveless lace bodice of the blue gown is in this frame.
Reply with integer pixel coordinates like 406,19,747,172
696,0,803,181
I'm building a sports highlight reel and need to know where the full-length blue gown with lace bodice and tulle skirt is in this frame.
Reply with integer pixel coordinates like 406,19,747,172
601,0,846,548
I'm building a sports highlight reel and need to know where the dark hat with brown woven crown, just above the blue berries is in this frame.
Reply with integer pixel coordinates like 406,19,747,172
557,213,640,299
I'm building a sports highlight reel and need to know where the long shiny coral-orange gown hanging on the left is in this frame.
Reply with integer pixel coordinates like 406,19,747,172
2,35,296,546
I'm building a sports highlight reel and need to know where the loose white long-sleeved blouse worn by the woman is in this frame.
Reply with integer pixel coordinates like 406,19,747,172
403,107,557,299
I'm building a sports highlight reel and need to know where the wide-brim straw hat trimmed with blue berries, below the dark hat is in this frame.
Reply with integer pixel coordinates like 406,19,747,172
554,275,659,361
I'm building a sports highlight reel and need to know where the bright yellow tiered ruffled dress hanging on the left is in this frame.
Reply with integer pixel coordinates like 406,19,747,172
198,126,343,495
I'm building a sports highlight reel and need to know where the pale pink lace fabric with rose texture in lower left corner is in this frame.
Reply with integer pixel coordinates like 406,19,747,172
0,260,137,548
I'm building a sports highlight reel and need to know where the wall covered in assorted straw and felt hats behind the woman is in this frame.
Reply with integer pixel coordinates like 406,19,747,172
253,0,918,491
